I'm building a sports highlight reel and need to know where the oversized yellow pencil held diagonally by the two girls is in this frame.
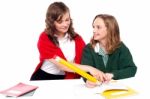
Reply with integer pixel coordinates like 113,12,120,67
54,56,100,84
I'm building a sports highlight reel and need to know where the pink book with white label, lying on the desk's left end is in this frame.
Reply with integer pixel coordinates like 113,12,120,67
0,83,38,97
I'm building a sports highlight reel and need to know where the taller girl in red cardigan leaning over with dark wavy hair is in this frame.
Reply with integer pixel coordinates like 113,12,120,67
30,2,101,80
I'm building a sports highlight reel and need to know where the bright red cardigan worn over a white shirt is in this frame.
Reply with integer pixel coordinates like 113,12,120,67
33,32,85,79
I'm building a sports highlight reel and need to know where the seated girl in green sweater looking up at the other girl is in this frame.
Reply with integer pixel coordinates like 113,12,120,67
81,14,137,87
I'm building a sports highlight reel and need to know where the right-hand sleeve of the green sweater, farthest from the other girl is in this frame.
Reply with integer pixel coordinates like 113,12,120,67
113,46,137,79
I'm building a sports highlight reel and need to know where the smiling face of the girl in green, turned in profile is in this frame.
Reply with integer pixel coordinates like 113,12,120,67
93,18,107,42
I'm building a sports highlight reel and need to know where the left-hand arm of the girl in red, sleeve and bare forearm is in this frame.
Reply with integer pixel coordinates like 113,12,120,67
38,32,77,72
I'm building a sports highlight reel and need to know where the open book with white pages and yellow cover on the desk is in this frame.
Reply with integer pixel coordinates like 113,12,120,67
74,81,137,99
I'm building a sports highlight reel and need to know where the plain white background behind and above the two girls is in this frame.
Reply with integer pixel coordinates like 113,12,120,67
0,0,150,88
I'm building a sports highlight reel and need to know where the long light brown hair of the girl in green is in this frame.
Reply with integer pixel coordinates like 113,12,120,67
90,14,121,54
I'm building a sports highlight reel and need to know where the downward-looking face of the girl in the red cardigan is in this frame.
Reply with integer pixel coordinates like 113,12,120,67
54,12,70,36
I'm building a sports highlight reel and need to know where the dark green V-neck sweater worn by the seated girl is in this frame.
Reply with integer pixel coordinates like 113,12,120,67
81,42,137,80
